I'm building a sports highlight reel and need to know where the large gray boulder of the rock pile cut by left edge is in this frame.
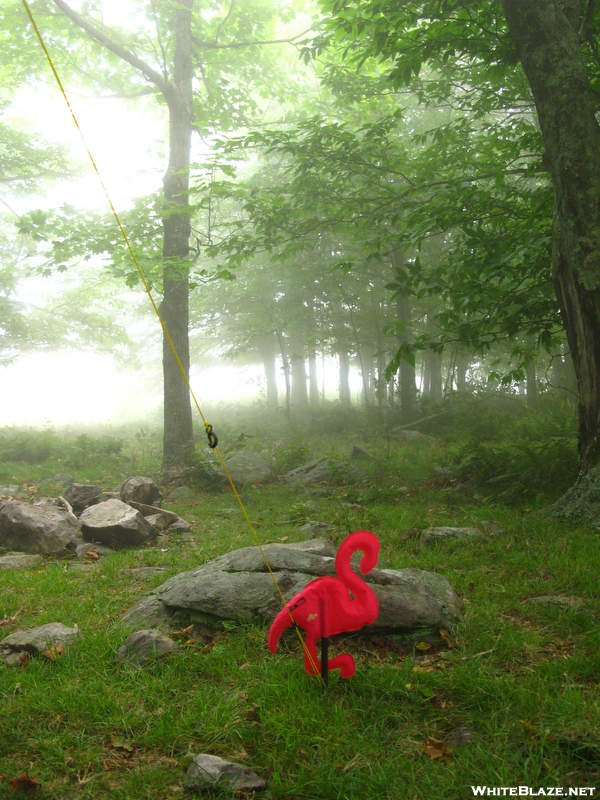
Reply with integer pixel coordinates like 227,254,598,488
0,500,80,556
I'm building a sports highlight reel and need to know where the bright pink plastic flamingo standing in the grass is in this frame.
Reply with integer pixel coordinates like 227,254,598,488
269,531,379,678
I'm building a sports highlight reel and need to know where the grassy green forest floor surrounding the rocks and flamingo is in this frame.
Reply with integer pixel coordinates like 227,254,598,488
0,404,600,800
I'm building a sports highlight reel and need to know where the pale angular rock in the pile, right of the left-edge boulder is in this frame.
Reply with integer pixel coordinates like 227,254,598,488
80,500,158,547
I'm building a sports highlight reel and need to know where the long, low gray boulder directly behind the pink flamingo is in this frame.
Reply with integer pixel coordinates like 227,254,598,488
122,539,462,631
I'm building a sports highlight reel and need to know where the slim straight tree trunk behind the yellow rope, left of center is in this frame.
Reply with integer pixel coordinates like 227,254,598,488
160,0,194,467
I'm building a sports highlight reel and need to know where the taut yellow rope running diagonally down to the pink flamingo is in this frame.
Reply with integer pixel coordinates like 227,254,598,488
22,0,325,685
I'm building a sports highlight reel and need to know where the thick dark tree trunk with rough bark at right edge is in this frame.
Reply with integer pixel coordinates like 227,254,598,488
503,0,600,523
